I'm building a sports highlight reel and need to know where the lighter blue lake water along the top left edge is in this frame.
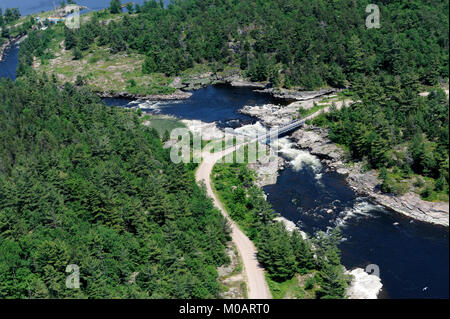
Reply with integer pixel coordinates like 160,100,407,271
0,0,170,15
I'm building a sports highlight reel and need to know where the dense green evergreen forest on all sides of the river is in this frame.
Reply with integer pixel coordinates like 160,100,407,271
0,0,449,298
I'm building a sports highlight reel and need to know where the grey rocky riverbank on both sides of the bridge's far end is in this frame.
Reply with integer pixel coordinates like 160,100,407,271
242,92,449,227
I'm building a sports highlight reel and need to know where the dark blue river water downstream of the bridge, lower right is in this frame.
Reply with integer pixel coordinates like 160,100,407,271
264,168,449,298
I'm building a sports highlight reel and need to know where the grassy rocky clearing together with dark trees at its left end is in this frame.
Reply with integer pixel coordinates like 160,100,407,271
18,18,176,96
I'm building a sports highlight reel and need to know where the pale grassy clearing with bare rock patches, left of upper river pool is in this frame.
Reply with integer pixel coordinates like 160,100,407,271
33,25,176,96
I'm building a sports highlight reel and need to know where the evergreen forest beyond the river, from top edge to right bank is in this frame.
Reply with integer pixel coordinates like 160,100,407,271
19,0,442,201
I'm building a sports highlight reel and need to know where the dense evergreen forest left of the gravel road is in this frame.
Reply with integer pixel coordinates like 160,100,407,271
0,75,229,298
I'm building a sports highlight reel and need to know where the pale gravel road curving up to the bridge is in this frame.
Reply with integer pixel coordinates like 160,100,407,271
195,147,272,299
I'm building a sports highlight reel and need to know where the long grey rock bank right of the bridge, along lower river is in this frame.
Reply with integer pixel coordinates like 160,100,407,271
292,127,449,226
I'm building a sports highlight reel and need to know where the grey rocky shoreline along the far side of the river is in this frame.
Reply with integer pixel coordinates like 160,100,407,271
4,30,449,227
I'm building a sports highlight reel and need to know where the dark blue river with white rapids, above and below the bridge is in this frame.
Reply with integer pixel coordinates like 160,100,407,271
0,6,449,298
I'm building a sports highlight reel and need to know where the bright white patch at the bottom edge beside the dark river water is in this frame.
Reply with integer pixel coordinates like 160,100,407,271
346,268,383,299
